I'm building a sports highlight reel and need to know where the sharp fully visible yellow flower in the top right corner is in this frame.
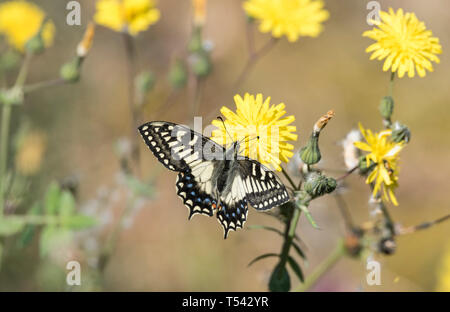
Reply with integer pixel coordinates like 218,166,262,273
363,8,442,78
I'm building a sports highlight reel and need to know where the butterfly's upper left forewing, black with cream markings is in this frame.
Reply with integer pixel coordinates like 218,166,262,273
138,121,225,172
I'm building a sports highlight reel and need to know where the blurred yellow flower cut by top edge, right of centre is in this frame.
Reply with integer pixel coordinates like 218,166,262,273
244,0,329,42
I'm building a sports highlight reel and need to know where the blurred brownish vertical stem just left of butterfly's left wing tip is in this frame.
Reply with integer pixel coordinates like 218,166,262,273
122,33,140,176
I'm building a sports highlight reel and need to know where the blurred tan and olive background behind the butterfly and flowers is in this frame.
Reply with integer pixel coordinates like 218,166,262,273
0,0,450,291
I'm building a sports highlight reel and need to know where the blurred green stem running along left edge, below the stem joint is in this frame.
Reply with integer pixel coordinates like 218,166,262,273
0,103,11,217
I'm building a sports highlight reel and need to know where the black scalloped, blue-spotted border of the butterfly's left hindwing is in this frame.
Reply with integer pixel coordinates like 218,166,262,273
176,172,217,219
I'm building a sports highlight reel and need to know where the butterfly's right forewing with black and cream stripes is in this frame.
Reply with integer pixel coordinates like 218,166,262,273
238,157,289,210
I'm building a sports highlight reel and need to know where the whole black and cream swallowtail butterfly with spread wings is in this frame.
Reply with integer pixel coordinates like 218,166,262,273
138,121,290,238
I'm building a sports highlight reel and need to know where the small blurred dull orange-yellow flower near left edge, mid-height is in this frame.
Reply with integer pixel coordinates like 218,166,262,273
15,132,47,176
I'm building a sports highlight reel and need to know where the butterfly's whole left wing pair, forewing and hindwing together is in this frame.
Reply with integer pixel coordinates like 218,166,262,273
139,121,225,219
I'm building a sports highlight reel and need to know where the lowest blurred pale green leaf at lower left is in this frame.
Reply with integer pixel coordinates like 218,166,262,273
39,225,73,258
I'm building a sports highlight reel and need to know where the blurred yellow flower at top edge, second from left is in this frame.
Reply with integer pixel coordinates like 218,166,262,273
94,0,160,36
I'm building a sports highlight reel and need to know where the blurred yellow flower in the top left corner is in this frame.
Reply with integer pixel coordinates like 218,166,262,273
0,1,55,52
